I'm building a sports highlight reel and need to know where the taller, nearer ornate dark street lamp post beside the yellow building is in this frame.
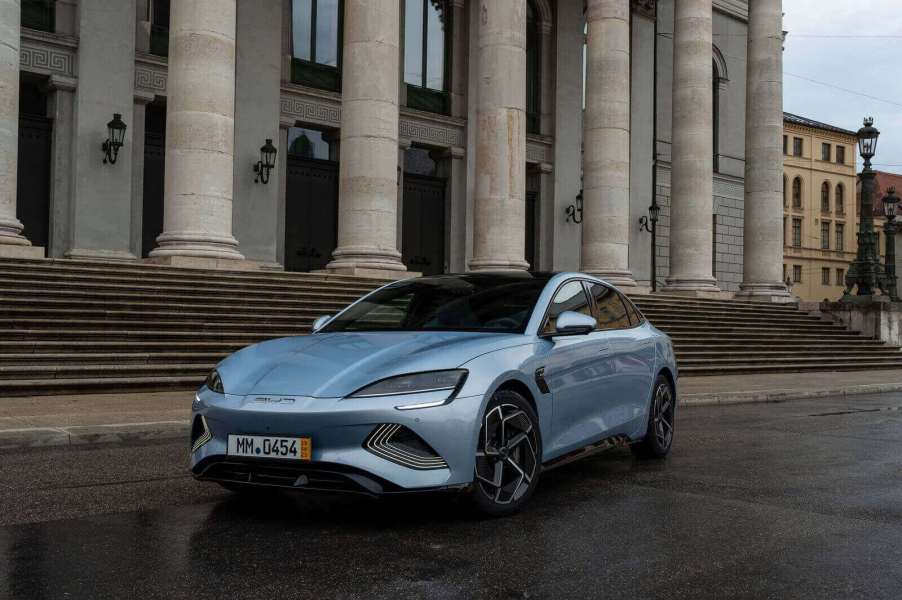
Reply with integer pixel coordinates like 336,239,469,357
840,117,889,303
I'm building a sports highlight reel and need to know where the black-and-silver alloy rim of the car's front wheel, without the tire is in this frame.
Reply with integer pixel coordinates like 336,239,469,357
476,404,539,504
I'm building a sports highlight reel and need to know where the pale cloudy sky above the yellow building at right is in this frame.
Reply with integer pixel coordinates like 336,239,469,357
783,0,902,173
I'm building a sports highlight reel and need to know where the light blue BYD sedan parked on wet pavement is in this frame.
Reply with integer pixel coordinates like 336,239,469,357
190,273,677,515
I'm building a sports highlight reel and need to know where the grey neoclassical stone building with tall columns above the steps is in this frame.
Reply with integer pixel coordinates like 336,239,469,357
0,0,788,300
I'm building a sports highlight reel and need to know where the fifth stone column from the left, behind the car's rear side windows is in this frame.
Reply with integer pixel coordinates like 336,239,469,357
581,0,640,286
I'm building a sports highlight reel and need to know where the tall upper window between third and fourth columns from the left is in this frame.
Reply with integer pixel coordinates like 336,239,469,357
404,0,451,114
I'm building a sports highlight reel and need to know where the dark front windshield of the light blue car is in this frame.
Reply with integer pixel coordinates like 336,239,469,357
322,274,548,333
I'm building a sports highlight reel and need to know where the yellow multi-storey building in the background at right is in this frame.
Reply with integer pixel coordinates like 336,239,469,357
783,113,860,302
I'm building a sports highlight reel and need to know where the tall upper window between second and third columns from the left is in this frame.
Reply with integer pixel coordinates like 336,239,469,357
291,0,342,90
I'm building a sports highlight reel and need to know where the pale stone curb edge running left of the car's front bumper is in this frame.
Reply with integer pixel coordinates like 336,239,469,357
0,421,189,450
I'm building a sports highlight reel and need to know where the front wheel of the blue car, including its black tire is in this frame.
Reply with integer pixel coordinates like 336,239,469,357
470,390,542,517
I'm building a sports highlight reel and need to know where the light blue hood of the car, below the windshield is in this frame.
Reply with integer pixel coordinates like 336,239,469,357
218,331,530,398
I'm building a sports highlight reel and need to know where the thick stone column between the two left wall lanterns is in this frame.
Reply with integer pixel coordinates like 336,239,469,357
150,0,244,266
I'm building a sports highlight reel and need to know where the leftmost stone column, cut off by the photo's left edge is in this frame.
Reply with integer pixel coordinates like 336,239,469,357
0,0,43,258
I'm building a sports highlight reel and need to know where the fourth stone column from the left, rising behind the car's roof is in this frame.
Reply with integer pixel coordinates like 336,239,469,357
470,0,529,271
